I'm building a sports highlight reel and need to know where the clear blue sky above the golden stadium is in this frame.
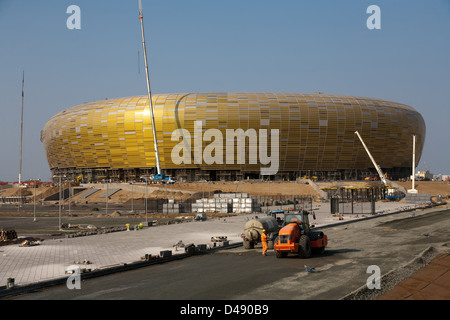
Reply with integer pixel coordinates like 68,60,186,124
0,0,450,181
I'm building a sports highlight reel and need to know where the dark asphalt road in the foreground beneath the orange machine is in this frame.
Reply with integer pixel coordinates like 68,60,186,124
4,210,450,300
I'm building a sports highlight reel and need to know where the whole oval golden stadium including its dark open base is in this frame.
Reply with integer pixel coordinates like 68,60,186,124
41,92,426,182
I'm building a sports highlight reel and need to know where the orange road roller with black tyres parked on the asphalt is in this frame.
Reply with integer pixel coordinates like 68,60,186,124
274,210,328,258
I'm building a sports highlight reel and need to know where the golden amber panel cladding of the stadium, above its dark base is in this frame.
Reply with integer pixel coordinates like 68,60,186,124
41,92,425,180
